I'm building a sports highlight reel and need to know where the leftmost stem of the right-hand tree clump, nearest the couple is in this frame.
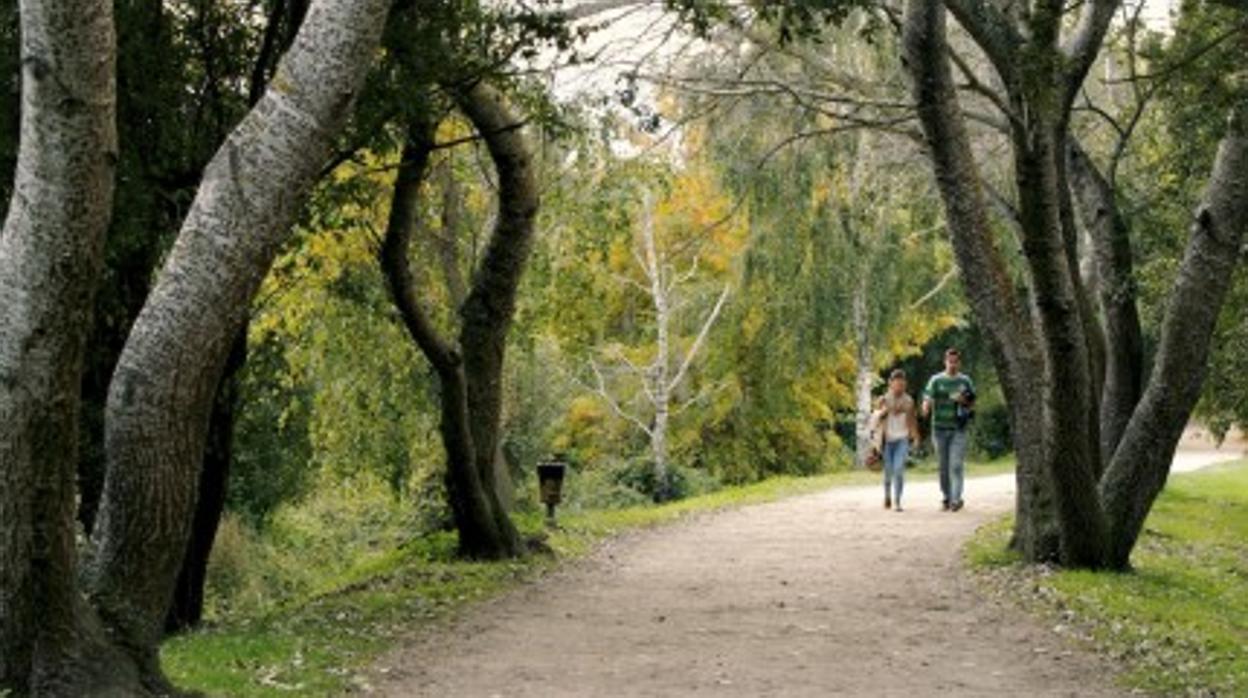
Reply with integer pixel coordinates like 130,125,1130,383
902,0,1057,561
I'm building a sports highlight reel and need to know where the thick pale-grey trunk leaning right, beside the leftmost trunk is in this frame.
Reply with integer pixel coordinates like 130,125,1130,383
87,0,389,689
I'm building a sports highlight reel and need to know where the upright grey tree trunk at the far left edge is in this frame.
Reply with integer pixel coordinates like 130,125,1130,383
0,0,121,696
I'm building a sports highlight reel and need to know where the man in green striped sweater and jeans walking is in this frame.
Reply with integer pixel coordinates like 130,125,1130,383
922,347,975,512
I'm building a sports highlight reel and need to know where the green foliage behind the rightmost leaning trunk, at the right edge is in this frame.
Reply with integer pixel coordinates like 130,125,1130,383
1093,0,1248,432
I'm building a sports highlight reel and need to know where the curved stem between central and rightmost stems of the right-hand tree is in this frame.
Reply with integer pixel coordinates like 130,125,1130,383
1067,139,1144,463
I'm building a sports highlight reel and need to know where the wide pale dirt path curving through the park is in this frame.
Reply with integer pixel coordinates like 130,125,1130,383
372,455,1243,698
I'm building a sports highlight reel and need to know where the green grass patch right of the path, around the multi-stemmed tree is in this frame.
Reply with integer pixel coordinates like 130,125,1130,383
966,461,1248,696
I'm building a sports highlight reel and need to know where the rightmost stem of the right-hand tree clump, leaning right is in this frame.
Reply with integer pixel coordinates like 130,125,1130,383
1101,108,1248,568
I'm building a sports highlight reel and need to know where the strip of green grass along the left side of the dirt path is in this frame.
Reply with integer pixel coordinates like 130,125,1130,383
162,458,1013,697
